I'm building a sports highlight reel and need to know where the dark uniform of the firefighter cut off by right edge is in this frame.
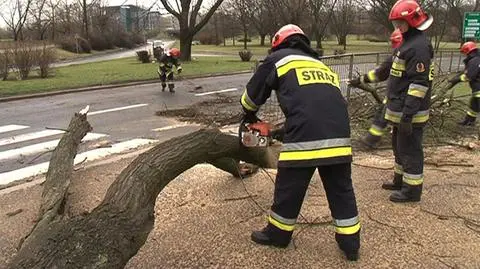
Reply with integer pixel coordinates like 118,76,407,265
458,49,480,125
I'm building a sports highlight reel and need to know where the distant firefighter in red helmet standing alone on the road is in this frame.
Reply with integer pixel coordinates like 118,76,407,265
157,48,182,93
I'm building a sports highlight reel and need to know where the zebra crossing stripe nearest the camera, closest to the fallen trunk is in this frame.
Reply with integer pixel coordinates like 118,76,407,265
0,139,157,185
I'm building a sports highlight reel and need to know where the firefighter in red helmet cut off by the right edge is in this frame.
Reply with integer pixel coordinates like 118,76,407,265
450,41,480,126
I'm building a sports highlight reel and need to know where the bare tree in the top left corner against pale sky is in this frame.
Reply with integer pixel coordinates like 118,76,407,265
0,0,33,41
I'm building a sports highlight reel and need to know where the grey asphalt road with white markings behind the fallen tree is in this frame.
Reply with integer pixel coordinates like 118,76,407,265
0,73,251,187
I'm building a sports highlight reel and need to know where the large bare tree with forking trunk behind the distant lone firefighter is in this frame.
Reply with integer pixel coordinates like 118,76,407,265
161,0,223,61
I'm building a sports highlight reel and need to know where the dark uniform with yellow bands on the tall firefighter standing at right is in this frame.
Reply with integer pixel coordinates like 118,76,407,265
385,28,433,202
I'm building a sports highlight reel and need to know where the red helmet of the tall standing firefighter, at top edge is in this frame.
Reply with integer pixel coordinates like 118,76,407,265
388,0,433,31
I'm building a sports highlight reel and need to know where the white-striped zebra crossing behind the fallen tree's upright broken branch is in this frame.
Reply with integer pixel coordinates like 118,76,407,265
0,124,156,188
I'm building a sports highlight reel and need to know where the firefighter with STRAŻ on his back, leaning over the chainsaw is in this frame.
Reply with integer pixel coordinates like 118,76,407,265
241,24,360,260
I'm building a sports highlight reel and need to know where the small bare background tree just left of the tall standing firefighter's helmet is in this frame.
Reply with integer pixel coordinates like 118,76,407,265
332,0,356,50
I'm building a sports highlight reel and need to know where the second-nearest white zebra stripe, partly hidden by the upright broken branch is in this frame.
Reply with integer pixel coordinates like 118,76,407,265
0,133,107,161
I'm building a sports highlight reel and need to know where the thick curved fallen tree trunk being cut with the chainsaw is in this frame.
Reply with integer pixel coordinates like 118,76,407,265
9,126,278,269
